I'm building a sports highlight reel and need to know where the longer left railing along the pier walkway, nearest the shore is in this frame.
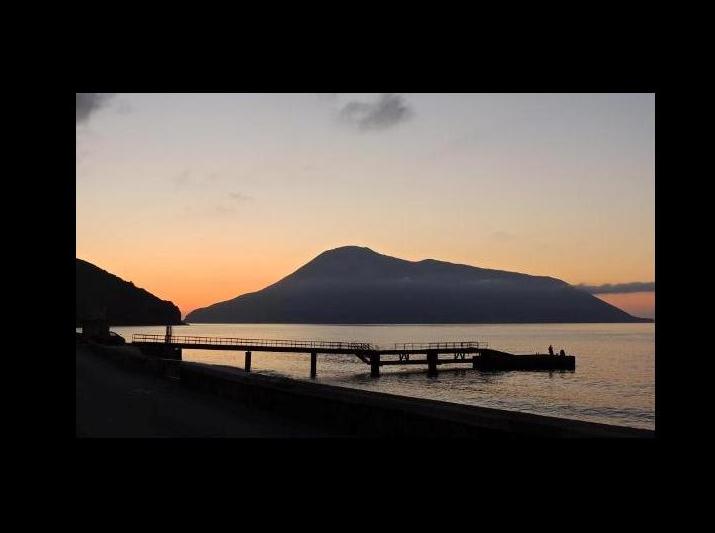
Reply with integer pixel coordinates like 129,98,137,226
132,333,376,351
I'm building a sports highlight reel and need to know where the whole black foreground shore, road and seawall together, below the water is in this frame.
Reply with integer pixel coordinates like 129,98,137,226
76,343,654,439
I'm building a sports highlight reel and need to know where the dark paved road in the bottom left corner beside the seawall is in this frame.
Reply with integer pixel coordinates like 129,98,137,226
76,345,340,438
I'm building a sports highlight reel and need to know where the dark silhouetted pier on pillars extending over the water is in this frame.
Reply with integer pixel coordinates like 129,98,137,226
132,330,576,378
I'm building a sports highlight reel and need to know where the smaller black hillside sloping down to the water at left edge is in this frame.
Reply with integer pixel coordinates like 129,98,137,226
75,258,182,327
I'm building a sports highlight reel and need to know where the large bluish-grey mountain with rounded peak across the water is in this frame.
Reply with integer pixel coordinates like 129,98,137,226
185,246,652,324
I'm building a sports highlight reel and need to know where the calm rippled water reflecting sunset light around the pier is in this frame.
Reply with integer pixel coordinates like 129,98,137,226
107,324,655,429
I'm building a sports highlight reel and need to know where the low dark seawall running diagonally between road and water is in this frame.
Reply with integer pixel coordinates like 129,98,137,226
82,346,655,438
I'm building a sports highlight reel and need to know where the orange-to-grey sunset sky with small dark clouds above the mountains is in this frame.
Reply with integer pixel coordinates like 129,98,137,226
76,93,655,317
